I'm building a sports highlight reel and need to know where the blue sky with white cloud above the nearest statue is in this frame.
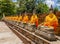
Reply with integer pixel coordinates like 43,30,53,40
45,0,60,10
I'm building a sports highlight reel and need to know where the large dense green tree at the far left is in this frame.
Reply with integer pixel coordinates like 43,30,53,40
1,0,15,15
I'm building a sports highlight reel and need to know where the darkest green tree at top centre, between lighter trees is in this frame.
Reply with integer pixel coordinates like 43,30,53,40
26,0,36,13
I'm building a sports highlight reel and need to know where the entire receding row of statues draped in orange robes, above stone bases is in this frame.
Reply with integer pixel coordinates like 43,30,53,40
4,11,58,31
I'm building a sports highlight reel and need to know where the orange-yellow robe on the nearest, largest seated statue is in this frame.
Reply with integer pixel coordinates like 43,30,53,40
44,14,58,31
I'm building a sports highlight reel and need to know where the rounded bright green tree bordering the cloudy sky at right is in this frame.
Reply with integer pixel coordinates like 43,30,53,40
36,3,49,14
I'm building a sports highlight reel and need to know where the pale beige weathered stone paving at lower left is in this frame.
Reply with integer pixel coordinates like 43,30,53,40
0,22,23,44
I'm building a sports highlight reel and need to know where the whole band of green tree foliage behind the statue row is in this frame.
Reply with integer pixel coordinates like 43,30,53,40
0,0,58,15
